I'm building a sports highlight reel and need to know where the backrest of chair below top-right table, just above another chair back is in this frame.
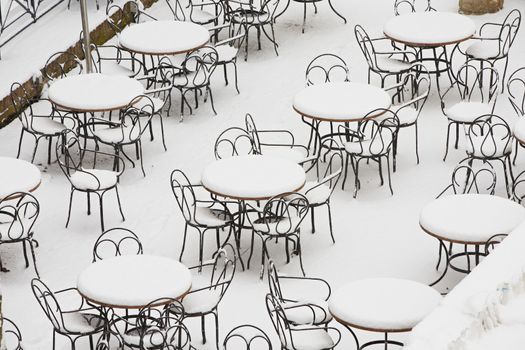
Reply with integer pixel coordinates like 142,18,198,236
454,61,499,103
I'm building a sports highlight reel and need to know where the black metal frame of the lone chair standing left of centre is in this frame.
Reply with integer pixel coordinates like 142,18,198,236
56,130,125,231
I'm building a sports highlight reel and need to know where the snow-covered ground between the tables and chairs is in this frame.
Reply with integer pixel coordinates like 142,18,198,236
0,0,525,350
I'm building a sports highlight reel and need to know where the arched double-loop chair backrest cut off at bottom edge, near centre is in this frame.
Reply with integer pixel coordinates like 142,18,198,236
222,324,272,350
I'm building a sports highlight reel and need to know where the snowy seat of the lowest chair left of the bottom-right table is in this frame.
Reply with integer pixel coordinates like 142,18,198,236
286,326,335,350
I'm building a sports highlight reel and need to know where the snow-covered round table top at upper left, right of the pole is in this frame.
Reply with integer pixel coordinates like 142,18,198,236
119,21,210,55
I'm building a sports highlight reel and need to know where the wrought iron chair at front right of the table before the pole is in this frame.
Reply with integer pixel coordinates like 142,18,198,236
86,95,155,176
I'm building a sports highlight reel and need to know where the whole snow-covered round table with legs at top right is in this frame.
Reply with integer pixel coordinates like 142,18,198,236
383,12,476,90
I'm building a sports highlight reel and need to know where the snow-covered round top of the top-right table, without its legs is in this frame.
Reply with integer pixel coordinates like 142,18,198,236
383,12,476,47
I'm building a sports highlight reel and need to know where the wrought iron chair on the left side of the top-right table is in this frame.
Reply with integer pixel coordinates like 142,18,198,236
354,25,416,87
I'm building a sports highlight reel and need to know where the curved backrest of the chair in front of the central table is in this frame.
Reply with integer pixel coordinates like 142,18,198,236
253,192,309,236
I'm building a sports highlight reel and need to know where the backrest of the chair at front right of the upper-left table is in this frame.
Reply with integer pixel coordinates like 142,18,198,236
182,46,219,87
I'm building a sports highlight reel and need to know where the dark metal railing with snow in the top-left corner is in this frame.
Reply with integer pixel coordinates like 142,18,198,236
0,0,64,56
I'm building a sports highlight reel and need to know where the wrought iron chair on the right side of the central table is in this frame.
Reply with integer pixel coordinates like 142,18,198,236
299,138,344,243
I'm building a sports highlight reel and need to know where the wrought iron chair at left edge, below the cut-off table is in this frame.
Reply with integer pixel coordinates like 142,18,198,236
0,192,40,276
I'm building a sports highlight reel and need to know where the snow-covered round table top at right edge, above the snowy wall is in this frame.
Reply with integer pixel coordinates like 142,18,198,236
419,194,525,244
